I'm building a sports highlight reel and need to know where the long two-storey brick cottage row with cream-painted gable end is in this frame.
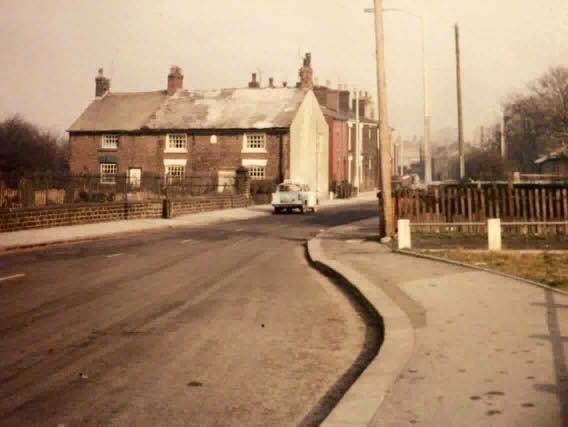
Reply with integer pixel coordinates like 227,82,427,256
68,66,328,198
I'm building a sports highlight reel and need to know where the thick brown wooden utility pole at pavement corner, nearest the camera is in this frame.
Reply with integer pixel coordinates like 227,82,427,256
374,0,394,238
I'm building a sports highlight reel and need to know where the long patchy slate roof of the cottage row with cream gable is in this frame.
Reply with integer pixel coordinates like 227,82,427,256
69,88,306,132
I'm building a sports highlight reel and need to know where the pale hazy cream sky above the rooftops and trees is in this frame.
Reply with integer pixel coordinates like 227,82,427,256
0,0,568,143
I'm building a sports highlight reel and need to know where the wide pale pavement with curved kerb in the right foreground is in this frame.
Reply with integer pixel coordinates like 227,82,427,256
319,220,568,427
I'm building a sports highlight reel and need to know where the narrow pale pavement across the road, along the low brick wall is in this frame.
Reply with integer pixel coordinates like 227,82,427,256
0,192,376,251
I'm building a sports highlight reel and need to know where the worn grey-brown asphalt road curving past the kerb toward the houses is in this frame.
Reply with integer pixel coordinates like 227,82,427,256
0,204,376,426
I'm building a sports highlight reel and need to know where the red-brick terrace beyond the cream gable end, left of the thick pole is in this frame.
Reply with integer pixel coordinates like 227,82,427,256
314,83,378,191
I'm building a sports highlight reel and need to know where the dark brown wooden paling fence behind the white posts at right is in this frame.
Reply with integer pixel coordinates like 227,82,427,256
393,185,568,234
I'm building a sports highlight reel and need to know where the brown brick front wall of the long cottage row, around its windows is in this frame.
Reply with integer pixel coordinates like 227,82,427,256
69,133,290,180
